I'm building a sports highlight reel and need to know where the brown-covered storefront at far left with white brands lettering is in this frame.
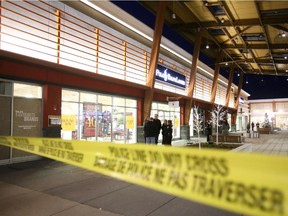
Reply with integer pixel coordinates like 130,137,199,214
0,79,42,164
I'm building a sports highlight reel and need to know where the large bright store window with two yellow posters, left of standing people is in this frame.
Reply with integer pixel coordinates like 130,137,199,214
62,90,137,143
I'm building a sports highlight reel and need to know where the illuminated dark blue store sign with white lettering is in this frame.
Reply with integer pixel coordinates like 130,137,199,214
155,64,186,88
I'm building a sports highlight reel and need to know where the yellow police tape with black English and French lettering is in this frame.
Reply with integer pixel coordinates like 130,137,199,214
0,137,288,216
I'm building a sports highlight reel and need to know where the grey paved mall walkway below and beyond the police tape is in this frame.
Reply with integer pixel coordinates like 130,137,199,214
0,132,288,216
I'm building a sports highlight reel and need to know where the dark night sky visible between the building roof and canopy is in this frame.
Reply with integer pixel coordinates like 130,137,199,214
112,1,288,99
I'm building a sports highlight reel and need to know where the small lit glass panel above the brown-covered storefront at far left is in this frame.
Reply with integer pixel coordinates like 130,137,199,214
14,83,42,98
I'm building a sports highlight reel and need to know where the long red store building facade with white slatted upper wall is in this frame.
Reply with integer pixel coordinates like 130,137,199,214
0,1,249,163
